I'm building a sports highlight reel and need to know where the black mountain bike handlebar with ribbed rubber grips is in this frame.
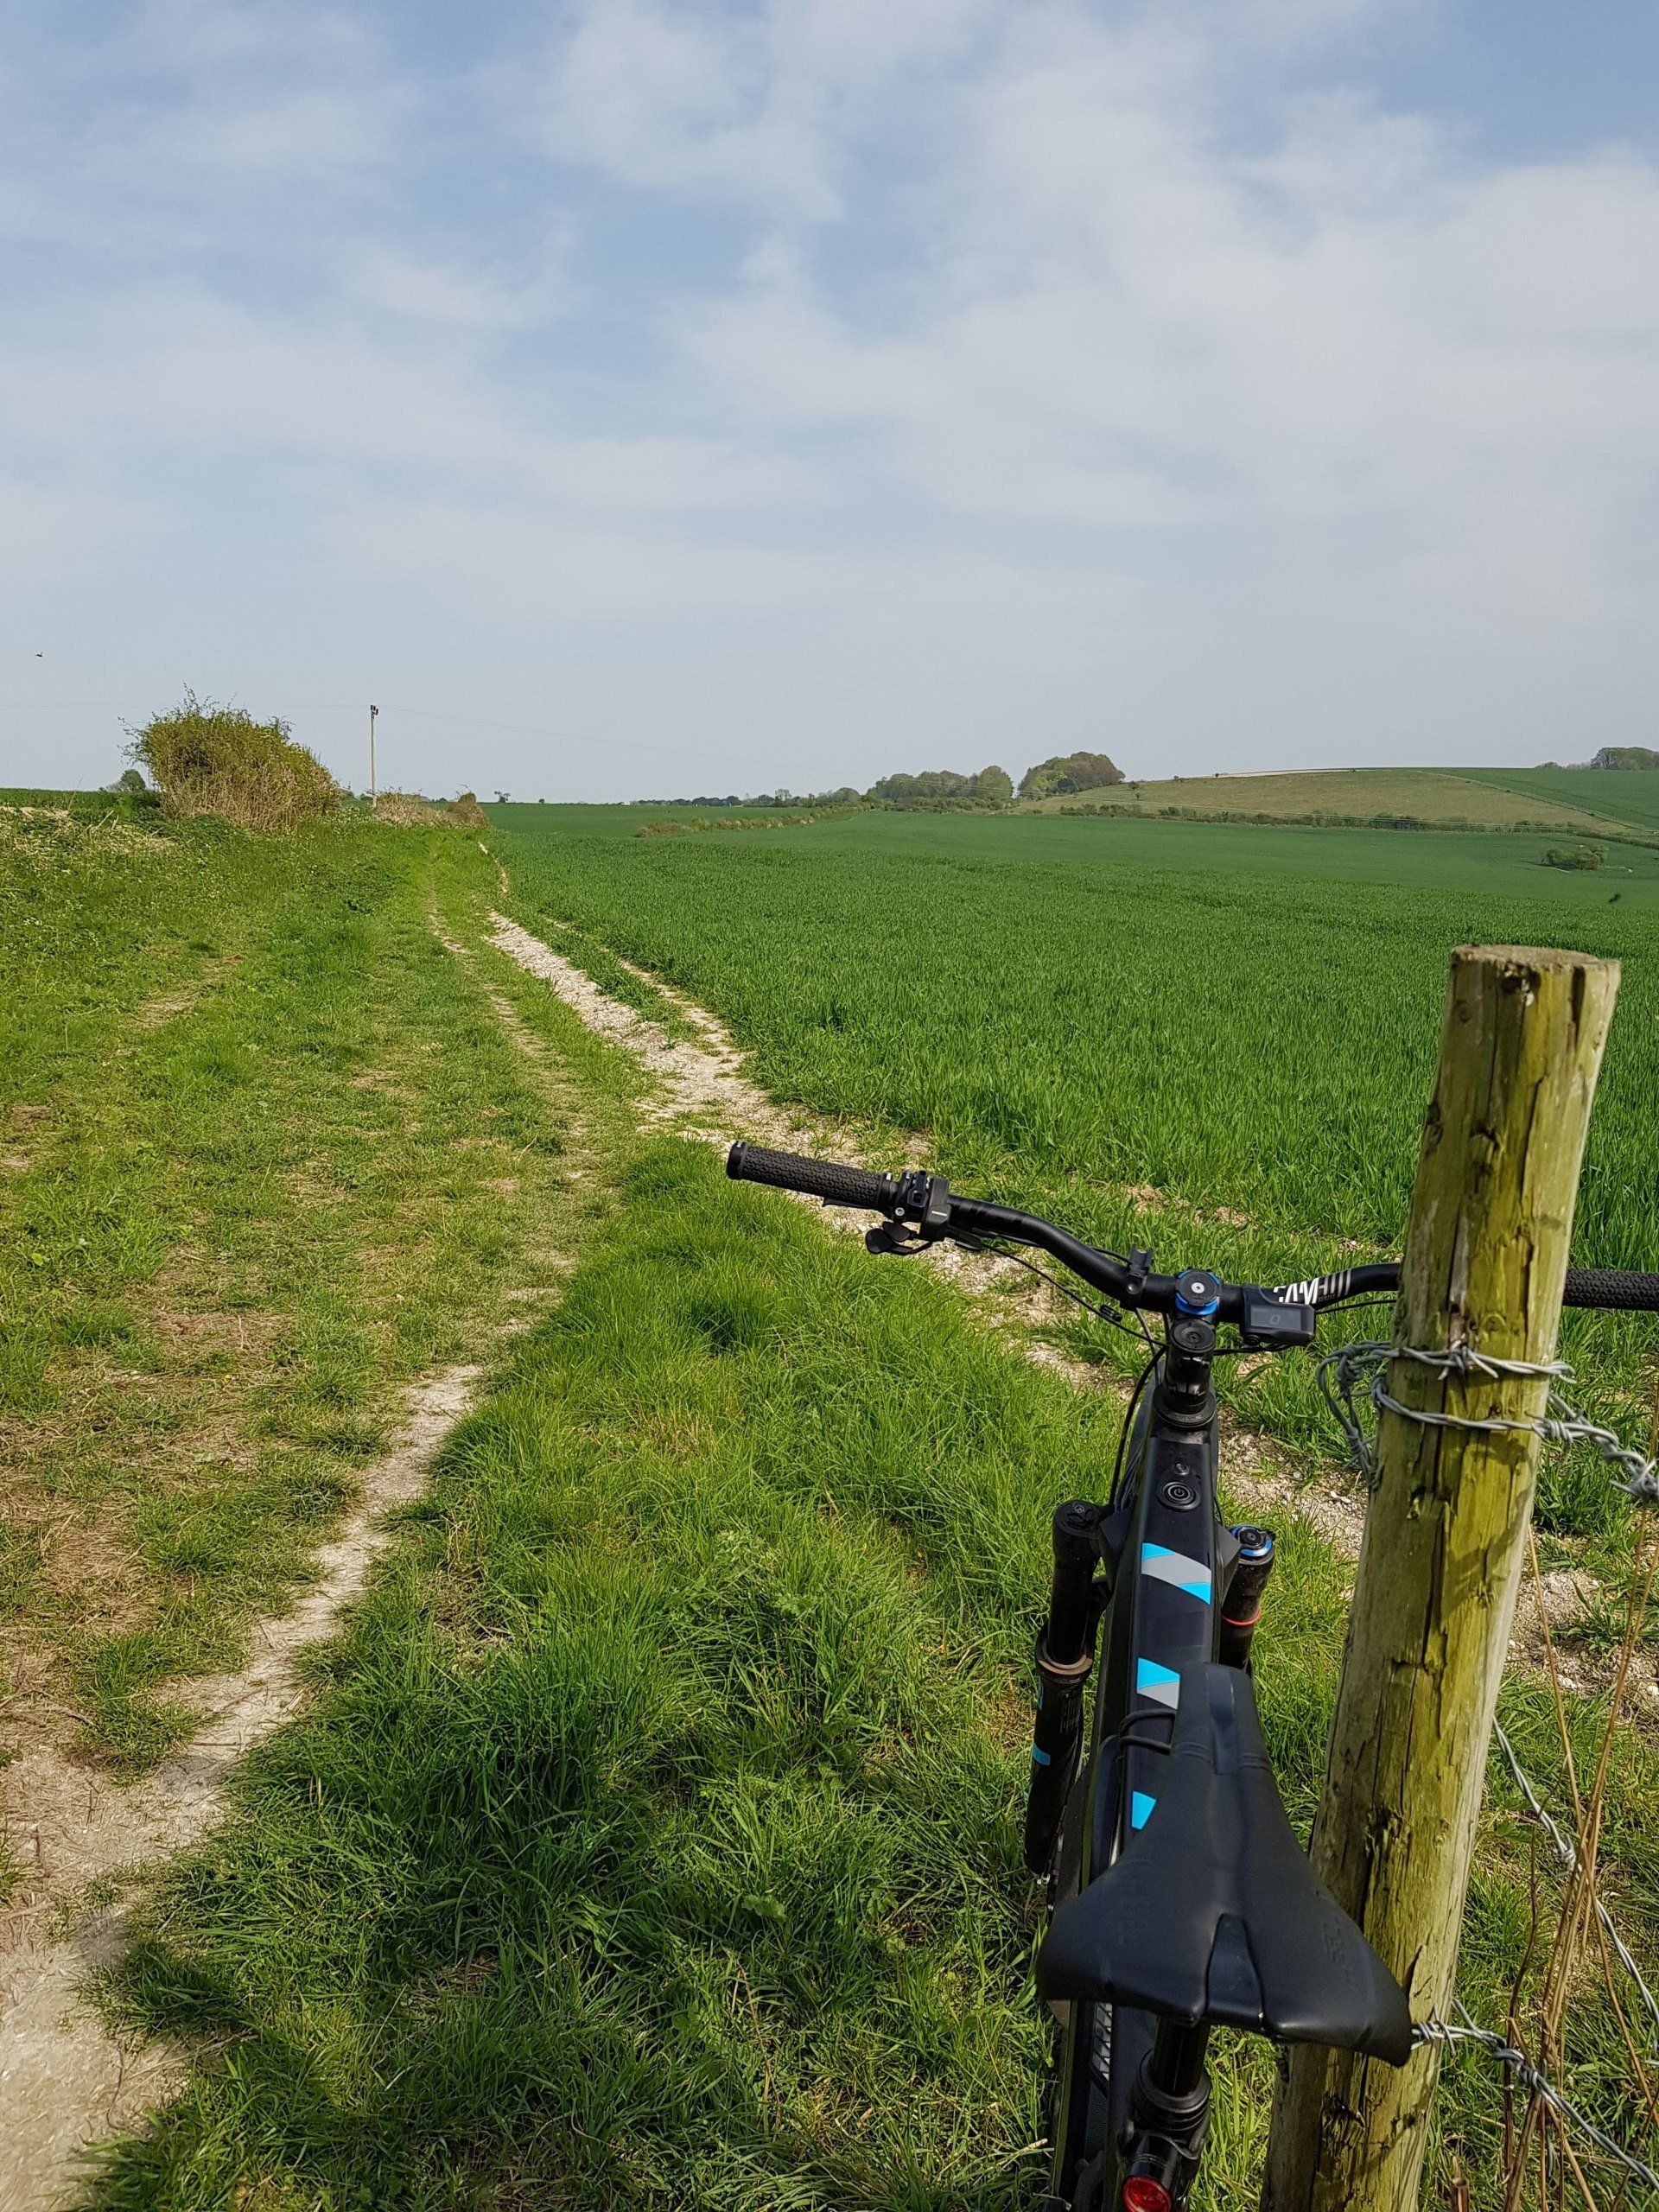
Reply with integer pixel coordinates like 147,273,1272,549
726,1144,1659,1325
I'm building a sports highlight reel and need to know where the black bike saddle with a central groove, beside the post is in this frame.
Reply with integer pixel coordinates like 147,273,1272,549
1038,1666,1411,2066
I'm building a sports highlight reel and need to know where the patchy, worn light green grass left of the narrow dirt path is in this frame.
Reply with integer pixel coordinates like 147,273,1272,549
0,821,560,1763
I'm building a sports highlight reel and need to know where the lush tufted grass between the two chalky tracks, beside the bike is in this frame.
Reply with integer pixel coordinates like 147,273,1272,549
93,1141,1659,2212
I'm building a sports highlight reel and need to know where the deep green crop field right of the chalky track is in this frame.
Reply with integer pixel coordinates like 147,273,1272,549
498,807,1659,1279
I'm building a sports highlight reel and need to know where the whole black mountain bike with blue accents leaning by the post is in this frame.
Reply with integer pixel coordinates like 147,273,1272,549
726,1144,1659,2212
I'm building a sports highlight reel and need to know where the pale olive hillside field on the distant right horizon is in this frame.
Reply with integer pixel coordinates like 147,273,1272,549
1031,767,1628,832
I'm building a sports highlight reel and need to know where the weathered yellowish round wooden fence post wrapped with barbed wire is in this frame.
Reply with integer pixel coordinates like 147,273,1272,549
1263,944,1619,2212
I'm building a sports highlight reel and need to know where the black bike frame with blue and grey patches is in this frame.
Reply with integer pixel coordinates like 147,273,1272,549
1039,1320,1265,2212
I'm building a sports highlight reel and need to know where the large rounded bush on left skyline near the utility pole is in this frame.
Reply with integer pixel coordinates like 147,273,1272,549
133,692,345,830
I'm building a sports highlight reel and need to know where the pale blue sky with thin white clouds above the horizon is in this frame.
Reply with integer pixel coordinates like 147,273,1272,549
0,0,1659,798
